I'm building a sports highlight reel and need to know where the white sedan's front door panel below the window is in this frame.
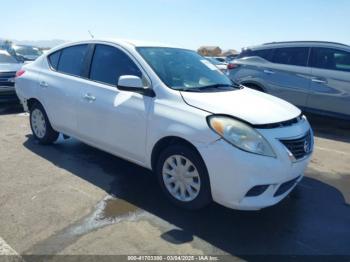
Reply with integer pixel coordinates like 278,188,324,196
76,81,152,163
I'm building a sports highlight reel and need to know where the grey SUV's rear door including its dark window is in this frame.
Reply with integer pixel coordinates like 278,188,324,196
261,47,311,107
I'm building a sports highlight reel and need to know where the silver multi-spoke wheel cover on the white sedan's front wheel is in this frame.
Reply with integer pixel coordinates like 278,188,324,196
162,155,201,202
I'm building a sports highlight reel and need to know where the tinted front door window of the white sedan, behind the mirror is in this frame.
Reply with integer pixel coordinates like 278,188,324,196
90,45,142,85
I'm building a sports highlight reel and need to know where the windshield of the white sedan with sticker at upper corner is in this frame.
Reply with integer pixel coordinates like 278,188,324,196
137,47,237,92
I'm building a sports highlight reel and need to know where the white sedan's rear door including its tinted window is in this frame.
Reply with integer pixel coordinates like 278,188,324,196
39,44,88,135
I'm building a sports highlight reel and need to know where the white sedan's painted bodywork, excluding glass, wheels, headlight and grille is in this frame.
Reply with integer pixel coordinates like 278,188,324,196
16,40,310,210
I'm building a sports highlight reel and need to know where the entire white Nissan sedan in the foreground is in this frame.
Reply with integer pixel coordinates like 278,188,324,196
16,40,313,210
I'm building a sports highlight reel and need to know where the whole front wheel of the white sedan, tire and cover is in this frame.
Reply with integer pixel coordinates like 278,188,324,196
156,145,212,210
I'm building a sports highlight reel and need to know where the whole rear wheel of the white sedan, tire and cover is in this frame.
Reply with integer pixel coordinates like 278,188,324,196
29,102,59,145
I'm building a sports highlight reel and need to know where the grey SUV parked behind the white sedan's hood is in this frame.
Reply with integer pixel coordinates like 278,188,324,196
229,41,350,119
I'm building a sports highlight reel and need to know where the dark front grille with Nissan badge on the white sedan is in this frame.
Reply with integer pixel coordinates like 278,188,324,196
280,131,312,160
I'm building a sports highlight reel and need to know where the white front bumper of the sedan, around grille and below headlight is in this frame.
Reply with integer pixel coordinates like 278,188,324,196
198,120,311,210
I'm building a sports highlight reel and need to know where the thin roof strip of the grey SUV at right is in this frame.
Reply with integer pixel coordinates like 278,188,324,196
245,41,350,50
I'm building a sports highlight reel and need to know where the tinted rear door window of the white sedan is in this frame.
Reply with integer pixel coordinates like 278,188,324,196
57,45,88,76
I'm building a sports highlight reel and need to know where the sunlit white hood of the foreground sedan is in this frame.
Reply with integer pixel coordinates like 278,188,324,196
181,88,301,125
